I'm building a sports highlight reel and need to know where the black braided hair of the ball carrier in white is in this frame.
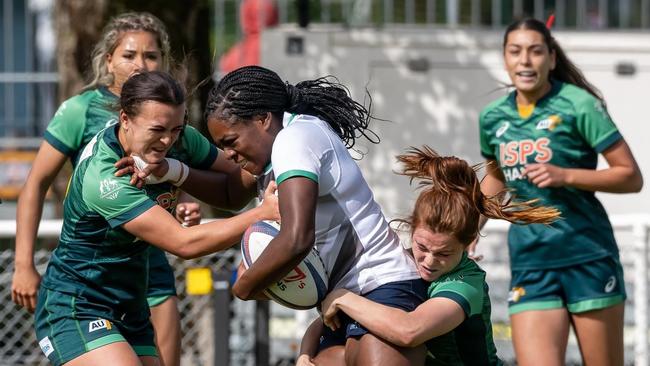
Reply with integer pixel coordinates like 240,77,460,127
204,66,379,148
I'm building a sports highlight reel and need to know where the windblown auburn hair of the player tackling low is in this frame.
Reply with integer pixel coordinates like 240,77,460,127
397,145,560,245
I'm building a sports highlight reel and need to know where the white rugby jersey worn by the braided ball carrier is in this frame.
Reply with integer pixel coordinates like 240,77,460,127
258,113,420,294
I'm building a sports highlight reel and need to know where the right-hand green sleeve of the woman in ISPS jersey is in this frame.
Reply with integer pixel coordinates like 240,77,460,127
576,94,622,153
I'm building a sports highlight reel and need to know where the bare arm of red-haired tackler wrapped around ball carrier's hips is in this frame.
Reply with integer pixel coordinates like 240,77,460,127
323,289,465,347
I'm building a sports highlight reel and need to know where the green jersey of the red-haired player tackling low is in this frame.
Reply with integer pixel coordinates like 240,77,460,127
426,253,501,366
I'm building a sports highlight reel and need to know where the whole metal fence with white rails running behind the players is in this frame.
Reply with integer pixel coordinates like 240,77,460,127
0,215,650,366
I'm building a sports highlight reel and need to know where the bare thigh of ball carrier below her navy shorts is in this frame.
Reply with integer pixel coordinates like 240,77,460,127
345,333,426,366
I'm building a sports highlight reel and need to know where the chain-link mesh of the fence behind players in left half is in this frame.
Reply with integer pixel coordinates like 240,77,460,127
0,250,264,366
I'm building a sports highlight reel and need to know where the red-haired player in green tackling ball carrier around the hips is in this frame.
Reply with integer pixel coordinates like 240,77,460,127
301,146,559,365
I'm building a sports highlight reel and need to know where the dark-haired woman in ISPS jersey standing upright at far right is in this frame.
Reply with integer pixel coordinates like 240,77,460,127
480,19,643,365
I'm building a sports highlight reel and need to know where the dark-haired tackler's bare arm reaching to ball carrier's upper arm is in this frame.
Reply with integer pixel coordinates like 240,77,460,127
123,184,280,259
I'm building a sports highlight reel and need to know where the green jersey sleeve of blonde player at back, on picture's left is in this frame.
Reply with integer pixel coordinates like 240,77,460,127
44,94,88,156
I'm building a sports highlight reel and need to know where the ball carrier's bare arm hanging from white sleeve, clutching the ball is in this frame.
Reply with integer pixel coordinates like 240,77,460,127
233,177,318,300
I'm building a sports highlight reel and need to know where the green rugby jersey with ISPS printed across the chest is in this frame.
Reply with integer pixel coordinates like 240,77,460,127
480,81,622,270
